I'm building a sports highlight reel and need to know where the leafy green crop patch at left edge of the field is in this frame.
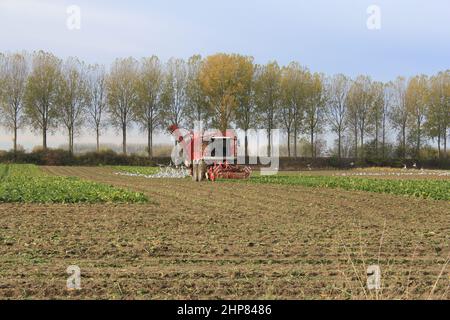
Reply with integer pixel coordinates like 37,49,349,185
0,165,148,203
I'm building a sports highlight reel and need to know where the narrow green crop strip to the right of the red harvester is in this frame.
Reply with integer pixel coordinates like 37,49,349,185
249,176,450,201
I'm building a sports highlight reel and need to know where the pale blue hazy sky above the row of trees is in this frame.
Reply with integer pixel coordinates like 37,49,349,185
0,0,450,149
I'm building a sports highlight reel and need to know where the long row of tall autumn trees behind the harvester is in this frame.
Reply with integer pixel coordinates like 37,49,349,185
0,51,450,158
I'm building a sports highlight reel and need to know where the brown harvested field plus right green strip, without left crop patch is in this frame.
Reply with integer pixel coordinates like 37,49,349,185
0,167,450,299
